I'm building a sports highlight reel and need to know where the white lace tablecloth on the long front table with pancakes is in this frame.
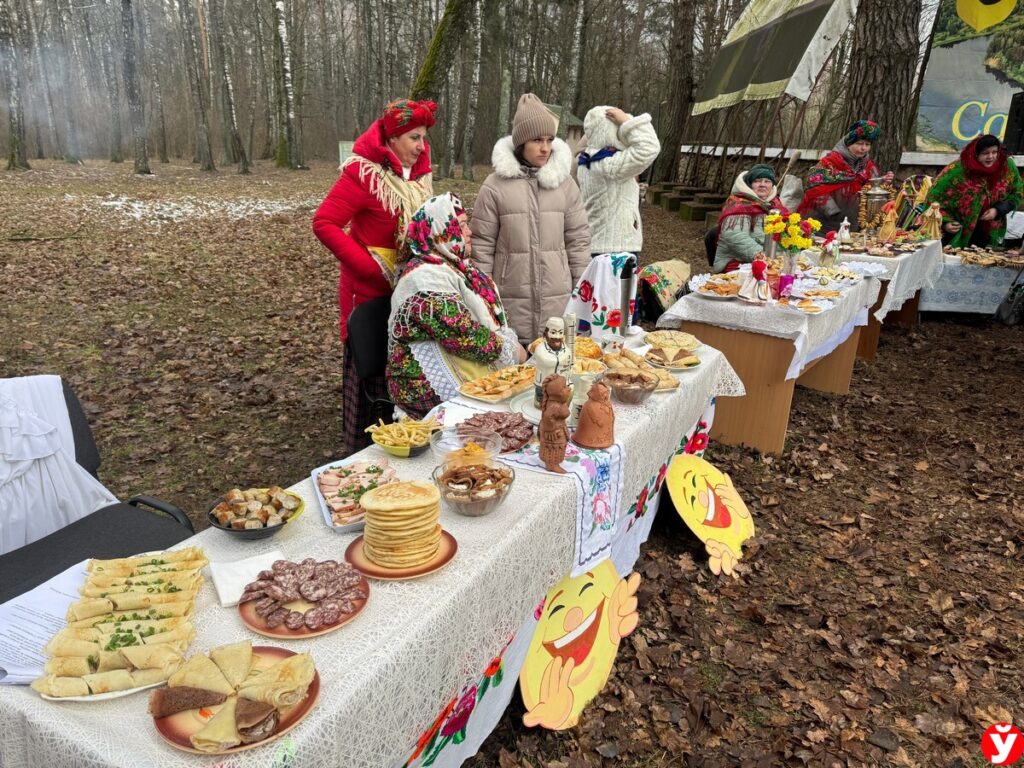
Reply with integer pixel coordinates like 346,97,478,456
0,347,743,768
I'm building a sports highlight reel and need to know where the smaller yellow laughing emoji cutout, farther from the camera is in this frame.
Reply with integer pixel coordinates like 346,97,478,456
665,454,754,578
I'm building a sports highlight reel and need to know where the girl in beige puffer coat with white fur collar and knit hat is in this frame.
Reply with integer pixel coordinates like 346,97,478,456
471,93,590,343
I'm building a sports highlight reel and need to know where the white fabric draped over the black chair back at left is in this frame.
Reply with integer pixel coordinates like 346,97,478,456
0,376,117,554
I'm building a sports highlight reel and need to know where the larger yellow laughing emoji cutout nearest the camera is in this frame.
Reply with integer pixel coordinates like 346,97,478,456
519,560,640,730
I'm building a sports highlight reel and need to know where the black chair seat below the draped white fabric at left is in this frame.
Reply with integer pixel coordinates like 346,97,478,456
0,503,193,603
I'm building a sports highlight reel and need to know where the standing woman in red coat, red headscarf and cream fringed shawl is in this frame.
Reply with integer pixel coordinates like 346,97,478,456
313,98,437,455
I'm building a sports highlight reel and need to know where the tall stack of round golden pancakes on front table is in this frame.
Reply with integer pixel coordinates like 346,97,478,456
359,480,441,568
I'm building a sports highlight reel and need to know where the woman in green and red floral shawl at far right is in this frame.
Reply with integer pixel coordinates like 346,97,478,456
928,133,1024,248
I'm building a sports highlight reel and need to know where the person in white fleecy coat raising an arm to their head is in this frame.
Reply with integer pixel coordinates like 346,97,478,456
577,106,662,255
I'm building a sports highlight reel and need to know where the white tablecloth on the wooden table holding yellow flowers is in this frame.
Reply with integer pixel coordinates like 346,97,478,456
657,278,881,379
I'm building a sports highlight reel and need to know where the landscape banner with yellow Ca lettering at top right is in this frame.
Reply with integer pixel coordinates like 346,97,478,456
916,0,1024,152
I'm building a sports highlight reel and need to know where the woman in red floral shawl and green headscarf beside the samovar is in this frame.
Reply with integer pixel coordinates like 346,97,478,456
797,120,893,229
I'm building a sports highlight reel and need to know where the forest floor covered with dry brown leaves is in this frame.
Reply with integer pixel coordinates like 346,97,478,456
0,162,1024,768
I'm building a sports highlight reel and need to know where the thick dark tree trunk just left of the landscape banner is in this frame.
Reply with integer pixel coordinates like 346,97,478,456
847,0,922,171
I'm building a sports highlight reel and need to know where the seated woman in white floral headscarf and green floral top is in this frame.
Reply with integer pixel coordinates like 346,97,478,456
387,193,526,418
